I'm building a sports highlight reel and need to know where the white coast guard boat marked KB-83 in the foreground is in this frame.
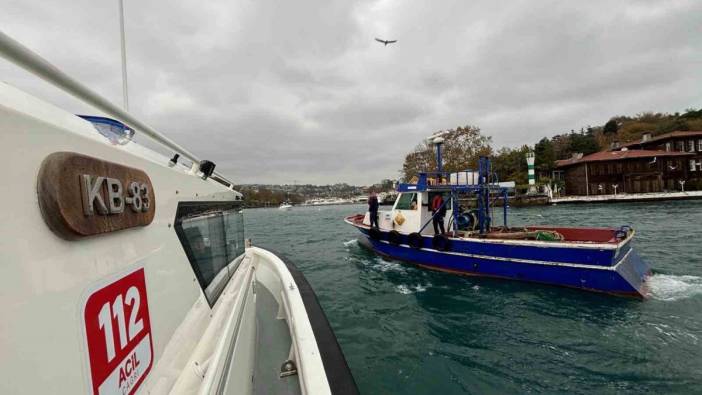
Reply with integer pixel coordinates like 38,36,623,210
0,32,357,394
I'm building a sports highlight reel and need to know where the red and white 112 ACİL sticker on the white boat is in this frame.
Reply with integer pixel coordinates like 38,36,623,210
83,268,153,395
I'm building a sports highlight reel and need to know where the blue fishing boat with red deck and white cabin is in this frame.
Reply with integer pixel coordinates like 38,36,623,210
345,138,651,298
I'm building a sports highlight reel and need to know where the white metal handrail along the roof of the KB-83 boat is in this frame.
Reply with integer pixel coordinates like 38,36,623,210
0,31,233,188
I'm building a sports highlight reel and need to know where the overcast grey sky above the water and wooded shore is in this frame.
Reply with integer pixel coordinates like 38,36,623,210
0,0,702,184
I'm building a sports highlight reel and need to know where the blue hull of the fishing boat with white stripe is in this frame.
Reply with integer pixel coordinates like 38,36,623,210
357,227,650,298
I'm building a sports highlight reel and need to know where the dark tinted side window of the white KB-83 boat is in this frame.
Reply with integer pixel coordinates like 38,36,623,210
175,202,244,306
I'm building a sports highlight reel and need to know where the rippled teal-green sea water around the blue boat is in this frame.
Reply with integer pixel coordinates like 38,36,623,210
245,201,702,394
